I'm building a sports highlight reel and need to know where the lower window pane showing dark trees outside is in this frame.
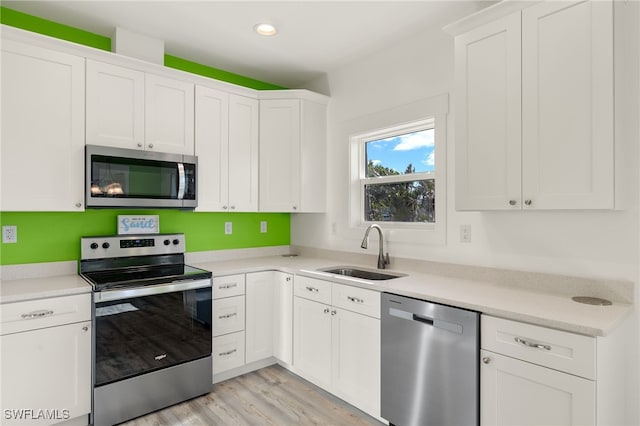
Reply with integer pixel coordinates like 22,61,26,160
364,179,436,223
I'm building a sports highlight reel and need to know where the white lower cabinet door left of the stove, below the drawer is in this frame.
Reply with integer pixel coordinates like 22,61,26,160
0,321,91,420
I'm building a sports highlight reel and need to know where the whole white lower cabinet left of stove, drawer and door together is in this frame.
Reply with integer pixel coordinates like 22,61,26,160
0,294,91,424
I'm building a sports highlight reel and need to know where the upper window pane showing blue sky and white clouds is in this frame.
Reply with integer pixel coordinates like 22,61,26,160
365,129,435,177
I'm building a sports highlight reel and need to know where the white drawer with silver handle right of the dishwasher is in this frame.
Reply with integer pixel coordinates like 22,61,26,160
480,315,596,380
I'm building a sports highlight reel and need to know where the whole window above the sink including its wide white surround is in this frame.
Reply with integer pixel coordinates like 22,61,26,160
343,94,449,246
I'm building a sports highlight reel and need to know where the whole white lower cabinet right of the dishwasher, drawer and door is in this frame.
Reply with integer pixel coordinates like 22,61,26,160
480,315,626,426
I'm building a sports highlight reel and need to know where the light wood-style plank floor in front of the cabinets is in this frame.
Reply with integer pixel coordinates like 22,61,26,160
122,365,382,426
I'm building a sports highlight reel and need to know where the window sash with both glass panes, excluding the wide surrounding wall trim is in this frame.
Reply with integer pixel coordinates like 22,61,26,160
360,120,436,223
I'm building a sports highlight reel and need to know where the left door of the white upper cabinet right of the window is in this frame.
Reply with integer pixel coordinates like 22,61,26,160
455,12,522,210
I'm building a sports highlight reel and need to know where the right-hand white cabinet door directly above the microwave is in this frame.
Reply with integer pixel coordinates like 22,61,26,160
145,74,194,155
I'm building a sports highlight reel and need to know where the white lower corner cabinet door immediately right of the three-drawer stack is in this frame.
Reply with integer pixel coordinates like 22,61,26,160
246,271,273,363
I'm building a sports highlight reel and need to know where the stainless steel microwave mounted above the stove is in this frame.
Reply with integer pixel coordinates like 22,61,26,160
85,145,198,209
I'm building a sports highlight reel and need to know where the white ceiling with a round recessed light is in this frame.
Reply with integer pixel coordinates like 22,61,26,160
2,0,494,88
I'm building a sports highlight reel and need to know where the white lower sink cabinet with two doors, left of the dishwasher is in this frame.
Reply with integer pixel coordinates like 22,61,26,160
293,276,380,417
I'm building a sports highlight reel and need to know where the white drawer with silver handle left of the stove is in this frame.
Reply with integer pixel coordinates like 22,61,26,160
0,293,91,335
